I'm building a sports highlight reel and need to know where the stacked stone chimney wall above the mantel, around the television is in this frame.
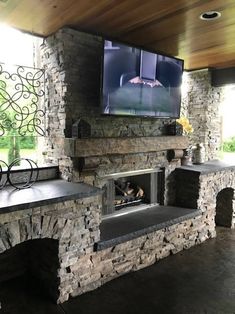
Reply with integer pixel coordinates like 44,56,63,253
41,28,173,137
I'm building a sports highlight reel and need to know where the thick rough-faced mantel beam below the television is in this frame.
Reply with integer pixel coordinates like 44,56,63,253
64,135,188,157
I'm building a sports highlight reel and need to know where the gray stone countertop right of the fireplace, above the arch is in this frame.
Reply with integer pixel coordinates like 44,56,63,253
177,160,235,174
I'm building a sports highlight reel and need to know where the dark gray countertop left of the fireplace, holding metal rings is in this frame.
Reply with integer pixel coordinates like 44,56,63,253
0,179,102,214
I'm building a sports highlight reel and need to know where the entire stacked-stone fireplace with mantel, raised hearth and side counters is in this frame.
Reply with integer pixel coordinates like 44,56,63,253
0,29,235,302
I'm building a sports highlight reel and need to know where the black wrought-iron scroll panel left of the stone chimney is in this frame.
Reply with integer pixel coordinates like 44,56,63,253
0,64,45,136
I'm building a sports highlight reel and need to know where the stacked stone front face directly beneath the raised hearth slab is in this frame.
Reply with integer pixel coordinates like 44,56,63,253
68,214,215,296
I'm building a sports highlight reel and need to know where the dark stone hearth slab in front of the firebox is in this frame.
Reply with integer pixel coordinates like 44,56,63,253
95,206,202,251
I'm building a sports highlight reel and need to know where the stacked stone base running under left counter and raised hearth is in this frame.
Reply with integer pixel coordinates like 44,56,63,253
0,196,215,302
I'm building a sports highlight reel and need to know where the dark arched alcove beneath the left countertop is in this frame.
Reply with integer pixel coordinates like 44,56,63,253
0,238,59,301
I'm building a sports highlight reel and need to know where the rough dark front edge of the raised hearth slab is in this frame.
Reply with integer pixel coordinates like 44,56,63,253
94,209,202,251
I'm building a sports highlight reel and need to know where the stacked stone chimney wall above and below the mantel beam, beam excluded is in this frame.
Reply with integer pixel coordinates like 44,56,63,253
41,28,178,184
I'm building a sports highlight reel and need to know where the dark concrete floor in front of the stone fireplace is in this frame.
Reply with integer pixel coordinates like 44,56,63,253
0,228,235,314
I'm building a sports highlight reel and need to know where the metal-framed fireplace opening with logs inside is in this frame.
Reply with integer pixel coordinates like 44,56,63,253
103,169,164,215
